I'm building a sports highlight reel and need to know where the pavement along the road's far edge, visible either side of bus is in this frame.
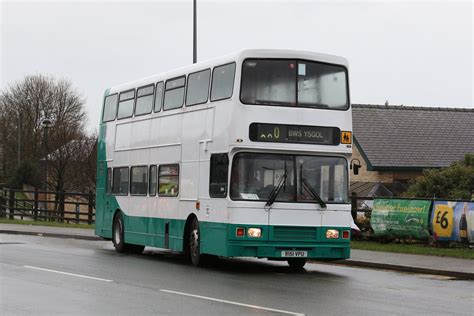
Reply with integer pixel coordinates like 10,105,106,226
0,224,474,280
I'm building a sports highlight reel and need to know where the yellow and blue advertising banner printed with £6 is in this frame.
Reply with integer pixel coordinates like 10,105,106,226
431,201,474,242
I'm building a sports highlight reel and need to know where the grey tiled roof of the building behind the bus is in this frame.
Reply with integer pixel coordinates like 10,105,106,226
352,104,474,170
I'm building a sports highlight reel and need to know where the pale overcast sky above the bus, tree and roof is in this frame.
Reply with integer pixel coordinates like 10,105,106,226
0,0,474,131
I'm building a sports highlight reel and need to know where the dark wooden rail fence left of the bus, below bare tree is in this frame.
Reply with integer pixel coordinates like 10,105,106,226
0,188,95,224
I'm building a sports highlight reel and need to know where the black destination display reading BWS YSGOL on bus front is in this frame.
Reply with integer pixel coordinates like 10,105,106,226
249,123,340,145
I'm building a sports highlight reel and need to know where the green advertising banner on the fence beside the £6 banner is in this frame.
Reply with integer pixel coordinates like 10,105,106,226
370,199,431,239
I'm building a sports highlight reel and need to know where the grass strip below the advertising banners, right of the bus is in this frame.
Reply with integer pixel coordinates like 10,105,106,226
351,240,474,259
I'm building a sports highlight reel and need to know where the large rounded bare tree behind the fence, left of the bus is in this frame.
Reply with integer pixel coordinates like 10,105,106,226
0,75,89,191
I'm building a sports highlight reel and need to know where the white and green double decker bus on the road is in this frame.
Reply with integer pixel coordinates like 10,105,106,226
95,49,352,269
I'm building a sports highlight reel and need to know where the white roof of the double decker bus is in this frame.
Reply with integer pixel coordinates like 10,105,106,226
107,49,348,94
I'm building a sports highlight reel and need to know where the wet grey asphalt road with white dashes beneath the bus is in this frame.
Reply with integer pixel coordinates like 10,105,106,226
0,235,474,316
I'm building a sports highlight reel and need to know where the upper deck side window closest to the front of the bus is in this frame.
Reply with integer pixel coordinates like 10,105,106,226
211,63,235,101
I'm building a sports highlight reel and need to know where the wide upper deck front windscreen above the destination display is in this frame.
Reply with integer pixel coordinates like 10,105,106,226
240,59,349,110
